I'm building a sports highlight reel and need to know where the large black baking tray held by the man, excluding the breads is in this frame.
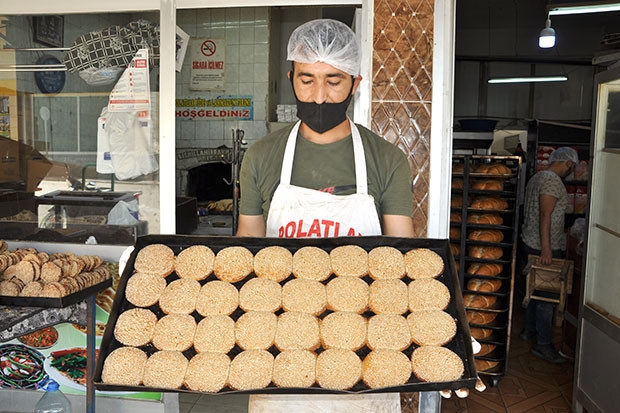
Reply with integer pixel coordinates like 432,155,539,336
93,235,477,394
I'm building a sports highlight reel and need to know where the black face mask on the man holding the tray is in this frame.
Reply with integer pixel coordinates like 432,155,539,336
291,71,355,133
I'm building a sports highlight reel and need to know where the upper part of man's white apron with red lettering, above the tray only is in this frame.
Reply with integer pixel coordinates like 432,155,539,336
266,120,381,238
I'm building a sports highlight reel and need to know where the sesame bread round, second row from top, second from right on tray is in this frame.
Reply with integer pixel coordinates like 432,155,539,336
368,278,409,314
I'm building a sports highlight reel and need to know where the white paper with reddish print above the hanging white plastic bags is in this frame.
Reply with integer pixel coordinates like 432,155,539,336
108,49,151,112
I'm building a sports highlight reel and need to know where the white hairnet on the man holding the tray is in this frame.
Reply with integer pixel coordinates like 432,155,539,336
286,19,360,76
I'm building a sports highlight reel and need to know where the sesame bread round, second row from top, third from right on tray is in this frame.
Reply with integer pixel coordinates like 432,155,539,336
325,277,370,314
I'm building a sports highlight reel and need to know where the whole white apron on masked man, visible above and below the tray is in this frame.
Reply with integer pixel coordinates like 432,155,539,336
254,121,401,413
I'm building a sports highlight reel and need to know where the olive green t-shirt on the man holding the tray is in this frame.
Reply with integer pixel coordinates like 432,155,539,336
239,125,413,227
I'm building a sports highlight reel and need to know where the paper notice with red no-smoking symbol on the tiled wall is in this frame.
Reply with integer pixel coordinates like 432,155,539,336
189,38,226,90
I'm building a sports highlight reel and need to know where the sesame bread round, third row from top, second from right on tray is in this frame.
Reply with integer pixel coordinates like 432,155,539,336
368,314,411,351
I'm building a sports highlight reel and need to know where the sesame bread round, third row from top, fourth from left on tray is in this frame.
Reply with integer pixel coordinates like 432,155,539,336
235,311,278,350
